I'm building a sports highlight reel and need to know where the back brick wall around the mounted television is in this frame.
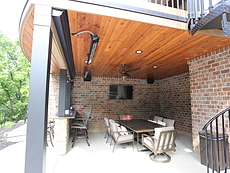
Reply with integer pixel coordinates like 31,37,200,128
71,77,159,131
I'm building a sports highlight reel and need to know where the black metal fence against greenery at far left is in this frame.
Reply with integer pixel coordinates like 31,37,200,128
0,105,28,127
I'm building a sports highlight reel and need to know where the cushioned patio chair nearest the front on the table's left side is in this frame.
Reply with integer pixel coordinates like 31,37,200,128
109,119,134,152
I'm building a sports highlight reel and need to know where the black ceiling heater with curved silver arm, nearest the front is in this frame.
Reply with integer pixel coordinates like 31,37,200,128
72,31,100,64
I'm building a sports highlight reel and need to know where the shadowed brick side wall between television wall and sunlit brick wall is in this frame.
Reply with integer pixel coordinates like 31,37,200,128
159,73,192,134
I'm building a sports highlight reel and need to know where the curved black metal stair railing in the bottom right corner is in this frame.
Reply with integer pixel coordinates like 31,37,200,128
200,108,230,173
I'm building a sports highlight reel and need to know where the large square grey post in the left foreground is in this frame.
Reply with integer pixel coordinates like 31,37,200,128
24,5,52,173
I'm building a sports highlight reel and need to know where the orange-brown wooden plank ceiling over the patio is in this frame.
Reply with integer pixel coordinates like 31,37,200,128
68,11,230,79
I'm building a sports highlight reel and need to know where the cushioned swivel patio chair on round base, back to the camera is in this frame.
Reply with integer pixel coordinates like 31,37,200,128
142,127,177,163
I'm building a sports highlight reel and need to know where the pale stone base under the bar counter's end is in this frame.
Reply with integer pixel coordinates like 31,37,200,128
54,118,70,155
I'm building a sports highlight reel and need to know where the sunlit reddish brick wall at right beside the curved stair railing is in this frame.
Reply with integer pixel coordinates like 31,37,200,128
188,47,230,151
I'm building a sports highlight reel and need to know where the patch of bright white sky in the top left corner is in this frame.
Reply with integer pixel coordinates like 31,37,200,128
0,0,26,40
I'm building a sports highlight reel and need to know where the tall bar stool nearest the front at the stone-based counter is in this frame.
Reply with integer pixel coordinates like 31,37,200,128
71,107,92,147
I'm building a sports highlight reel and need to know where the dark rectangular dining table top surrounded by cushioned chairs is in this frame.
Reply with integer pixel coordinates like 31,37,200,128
116,119,163,133
